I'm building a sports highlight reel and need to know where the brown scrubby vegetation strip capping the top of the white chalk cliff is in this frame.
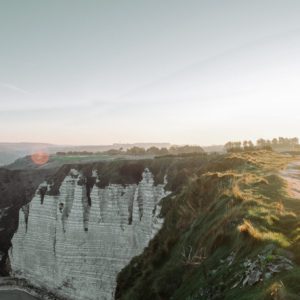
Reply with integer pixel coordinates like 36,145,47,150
48,153,210,195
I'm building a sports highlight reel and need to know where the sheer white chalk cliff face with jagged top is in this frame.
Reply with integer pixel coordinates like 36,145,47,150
10,169,167,300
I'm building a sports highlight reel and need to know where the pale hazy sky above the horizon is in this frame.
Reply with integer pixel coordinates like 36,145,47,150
0,0,300,145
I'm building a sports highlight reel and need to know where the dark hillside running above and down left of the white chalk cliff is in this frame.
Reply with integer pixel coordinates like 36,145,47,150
0,154,209,275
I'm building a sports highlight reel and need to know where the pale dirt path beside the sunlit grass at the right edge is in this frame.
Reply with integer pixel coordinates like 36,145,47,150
281,160,300,199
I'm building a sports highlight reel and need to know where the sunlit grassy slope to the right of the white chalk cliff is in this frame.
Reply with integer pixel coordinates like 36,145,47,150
116,151,300,300
